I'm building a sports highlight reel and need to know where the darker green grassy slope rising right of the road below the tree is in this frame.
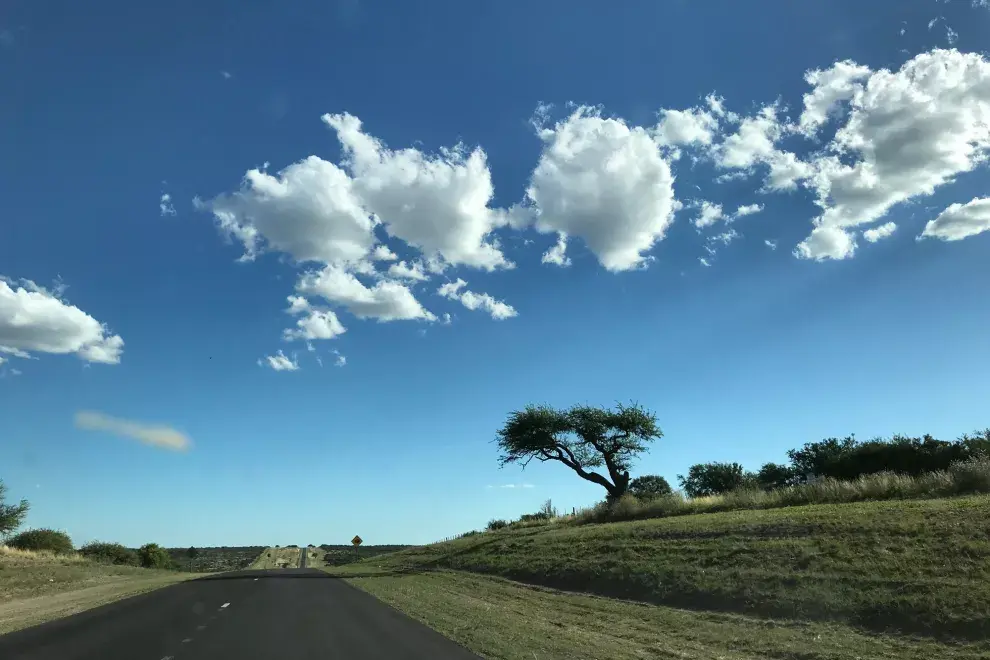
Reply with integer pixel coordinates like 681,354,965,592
336,496,990,639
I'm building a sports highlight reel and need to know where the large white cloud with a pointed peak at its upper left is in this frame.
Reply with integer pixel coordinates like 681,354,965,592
323,113,512,271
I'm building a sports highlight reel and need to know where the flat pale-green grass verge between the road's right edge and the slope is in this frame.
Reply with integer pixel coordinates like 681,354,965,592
342,562,990,660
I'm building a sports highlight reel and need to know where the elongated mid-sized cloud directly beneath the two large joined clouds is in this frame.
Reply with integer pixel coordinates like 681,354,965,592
296,266,436,321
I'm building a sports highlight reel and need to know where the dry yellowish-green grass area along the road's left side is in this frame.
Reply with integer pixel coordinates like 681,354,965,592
0,546,196,634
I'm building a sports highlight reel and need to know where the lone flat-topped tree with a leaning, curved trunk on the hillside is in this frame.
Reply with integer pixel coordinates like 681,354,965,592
495,404,663,501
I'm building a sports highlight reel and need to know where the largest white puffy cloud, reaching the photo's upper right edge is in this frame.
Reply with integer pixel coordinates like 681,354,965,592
798,49,990,261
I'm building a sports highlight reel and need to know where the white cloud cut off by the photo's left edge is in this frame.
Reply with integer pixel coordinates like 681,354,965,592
0,276,124,364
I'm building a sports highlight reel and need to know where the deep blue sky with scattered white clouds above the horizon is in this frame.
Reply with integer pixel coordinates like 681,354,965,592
0,0,990,546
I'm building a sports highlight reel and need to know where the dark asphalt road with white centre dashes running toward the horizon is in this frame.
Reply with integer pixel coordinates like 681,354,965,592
0,568,478,660
